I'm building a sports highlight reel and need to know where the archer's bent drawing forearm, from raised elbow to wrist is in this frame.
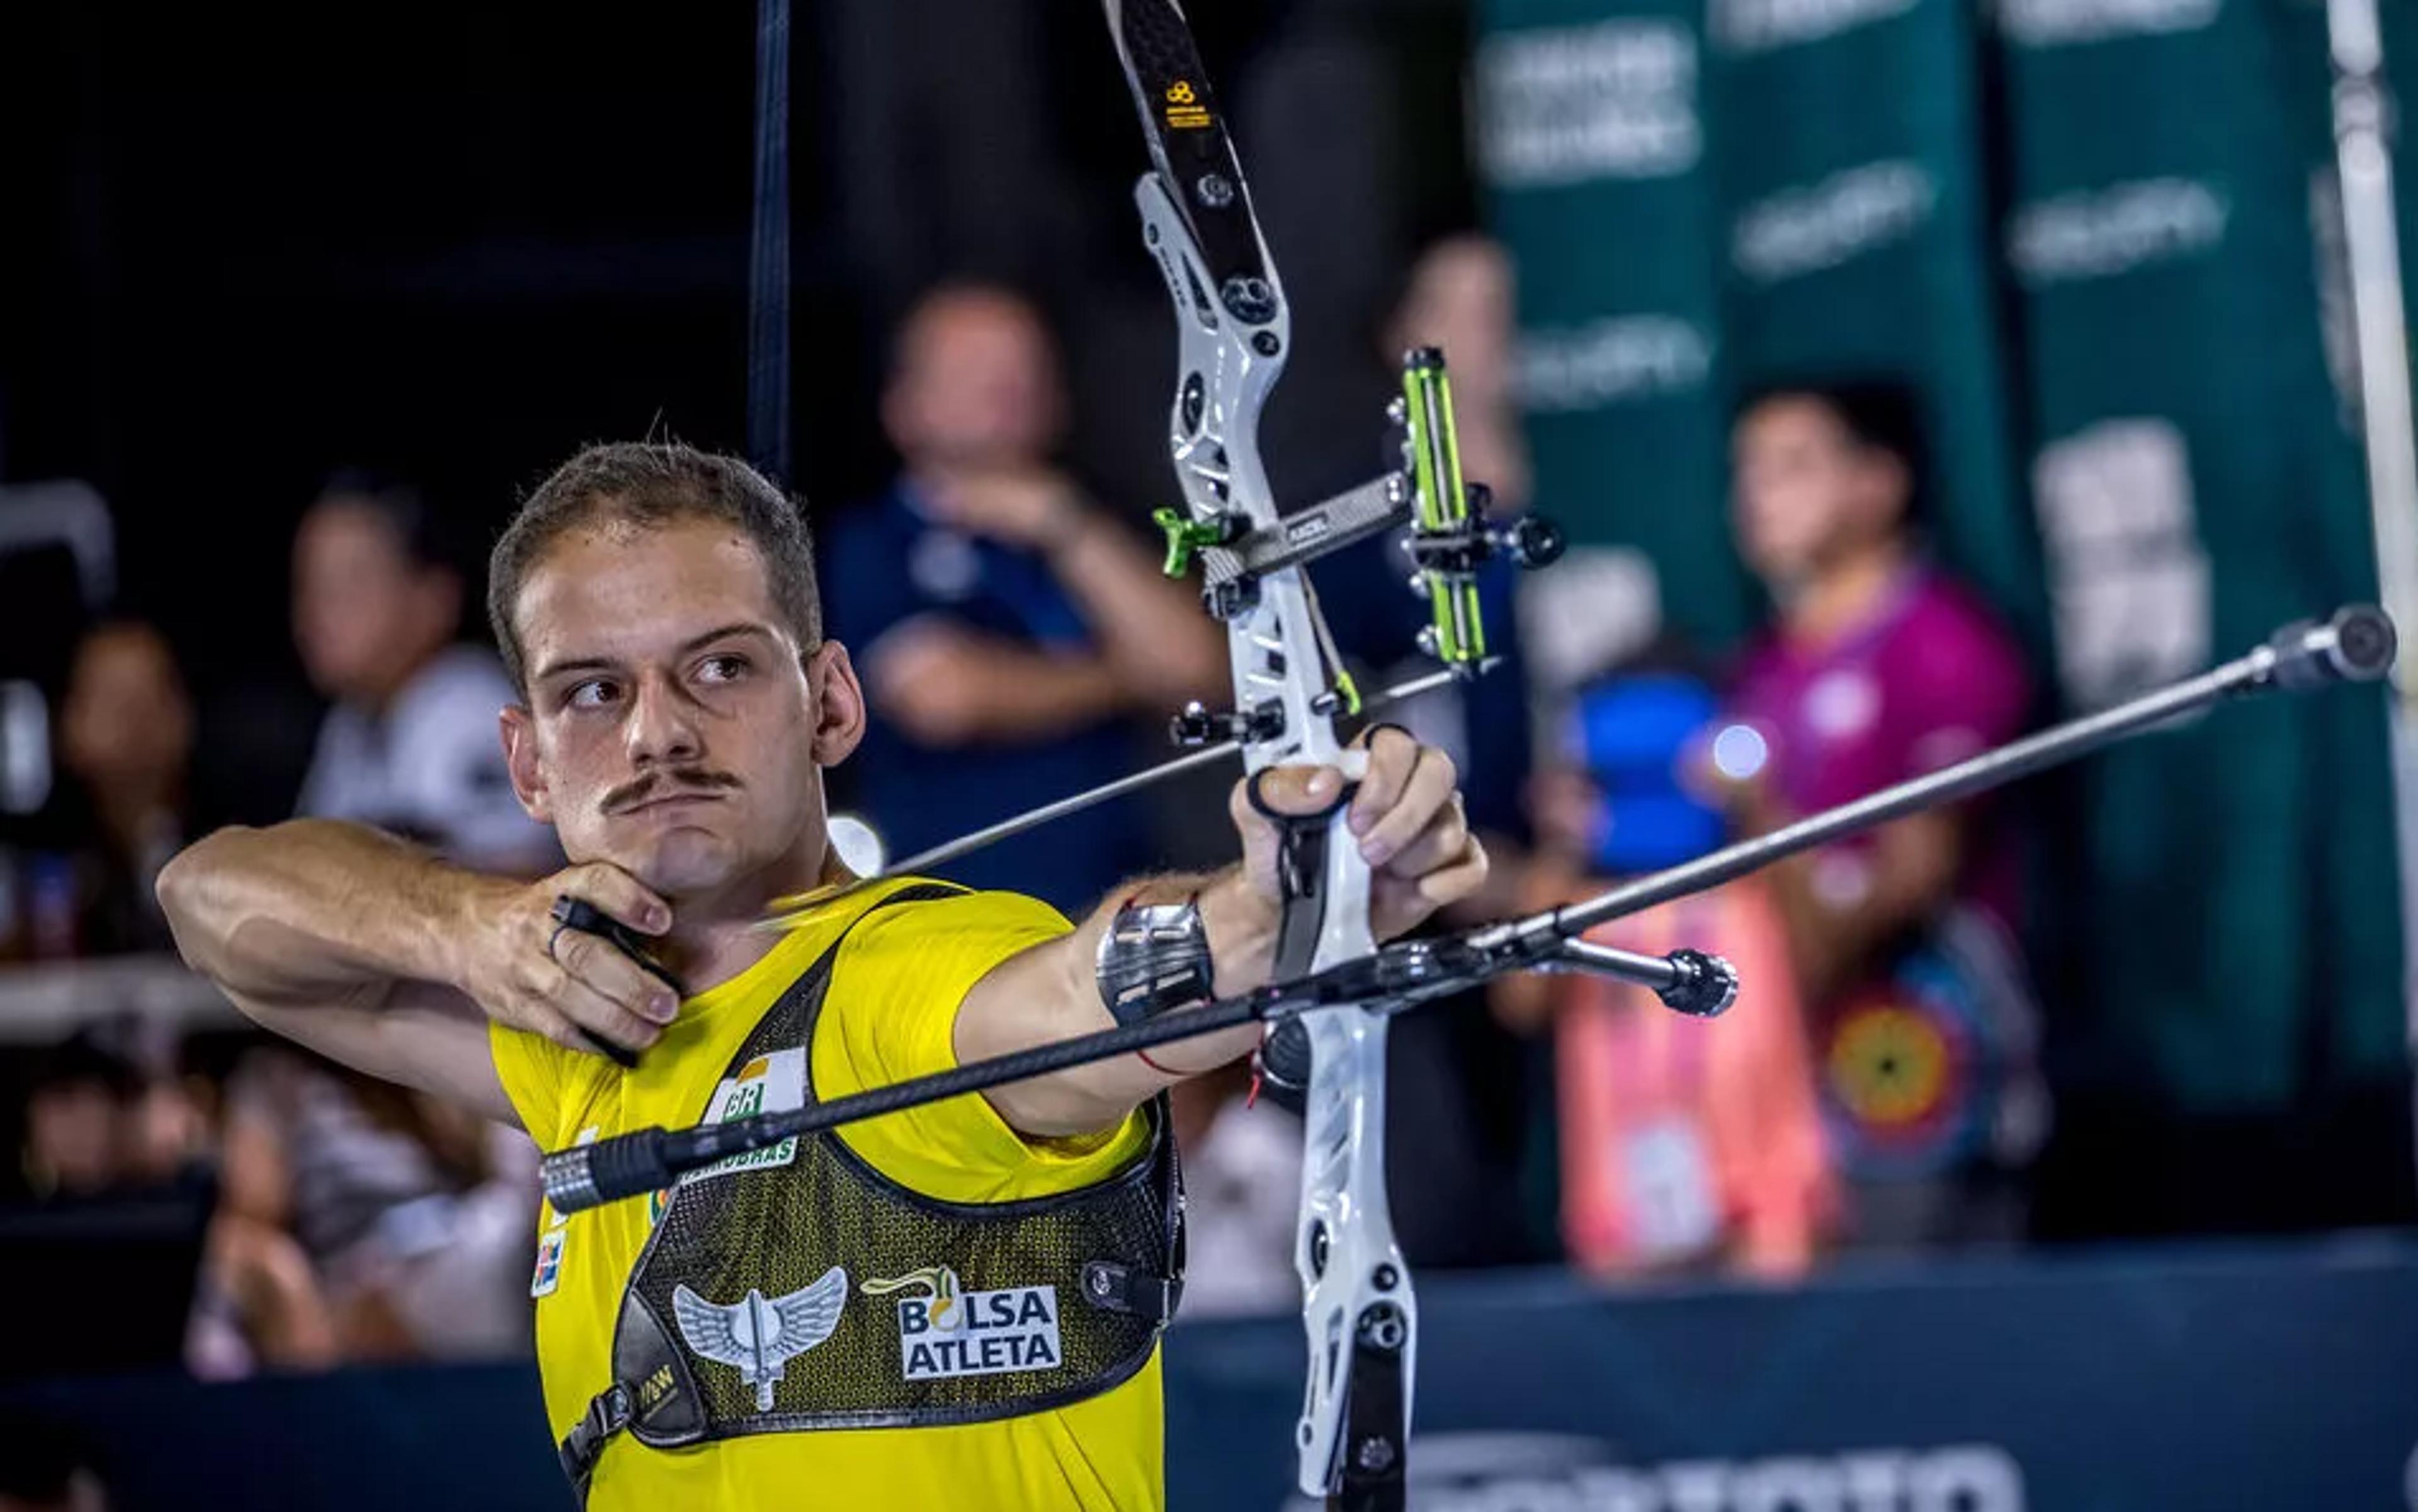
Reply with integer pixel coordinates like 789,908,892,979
159,820,515,1004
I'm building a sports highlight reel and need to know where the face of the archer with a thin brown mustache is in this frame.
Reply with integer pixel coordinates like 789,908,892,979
506,520,863,905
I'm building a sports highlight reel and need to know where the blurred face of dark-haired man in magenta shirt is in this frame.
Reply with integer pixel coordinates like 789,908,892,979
1731,397,1905,588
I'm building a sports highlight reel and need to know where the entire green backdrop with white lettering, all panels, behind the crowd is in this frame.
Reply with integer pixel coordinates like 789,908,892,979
1477,0,2406,1110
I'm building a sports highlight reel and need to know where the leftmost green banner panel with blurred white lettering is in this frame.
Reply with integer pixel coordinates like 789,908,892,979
1477,0,1751,641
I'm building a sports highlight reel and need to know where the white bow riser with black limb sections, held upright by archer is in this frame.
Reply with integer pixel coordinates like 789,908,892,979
1105,0,1424,1507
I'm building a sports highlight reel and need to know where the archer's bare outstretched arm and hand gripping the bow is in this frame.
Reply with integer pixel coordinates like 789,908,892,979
955,725,1487,1139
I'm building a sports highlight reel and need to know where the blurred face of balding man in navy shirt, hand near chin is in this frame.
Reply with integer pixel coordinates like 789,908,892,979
883,293,1062,469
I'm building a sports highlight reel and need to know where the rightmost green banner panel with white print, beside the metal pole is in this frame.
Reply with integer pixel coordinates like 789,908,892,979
2000,0,2404,1108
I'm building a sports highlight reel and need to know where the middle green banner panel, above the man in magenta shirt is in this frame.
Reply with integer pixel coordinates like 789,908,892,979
1707,0,2038,632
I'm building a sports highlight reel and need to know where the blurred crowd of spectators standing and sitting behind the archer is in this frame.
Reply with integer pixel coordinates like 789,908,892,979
0,217,2253,1377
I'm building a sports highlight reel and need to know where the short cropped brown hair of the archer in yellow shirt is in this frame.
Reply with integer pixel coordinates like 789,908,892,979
486,440,822,695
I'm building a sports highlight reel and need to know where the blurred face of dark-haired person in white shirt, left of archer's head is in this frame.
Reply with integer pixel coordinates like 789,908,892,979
295,498,460,702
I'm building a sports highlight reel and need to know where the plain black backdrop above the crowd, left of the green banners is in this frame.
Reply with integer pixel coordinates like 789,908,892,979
0,0,1470,817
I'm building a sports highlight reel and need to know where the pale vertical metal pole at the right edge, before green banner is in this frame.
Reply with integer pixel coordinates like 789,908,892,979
2326,0,2418,1055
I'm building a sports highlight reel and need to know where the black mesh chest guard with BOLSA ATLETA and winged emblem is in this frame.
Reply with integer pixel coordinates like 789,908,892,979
561,885,1183,1492
